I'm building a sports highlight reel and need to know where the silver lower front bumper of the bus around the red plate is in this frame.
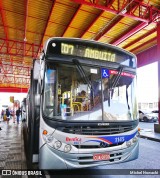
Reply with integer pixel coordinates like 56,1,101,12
39,142,139,169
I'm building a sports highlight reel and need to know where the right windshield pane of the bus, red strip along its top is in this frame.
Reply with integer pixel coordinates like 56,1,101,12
102,70,137,121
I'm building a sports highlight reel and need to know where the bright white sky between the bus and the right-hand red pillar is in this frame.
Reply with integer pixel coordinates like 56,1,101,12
137,62,158,102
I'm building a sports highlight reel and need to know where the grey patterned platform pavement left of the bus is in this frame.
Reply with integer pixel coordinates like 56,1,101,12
0,119,27,178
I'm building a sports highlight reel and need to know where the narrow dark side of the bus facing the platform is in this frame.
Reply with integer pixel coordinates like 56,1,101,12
28,61,40,166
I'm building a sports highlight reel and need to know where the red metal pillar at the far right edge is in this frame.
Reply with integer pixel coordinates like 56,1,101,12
154,22,160,133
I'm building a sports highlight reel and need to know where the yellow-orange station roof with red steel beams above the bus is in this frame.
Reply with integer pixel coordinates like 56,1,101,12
0,0,160,92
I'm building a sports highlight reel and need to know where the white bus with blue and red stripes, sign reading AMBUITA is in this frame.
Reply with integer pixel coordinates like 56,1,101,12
24,38,139,170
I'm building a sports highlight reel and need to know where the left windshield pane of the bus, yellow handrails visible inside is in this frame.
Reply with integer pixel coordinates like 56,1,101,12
44,64,102,120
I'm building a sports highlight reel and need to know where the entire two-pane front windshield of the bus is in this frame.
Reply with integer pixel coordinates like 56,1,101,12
43,60,137,121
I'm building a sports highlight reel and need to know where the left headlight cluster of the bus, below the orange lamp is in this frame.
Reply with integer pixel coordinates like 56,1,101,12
43,131,72,153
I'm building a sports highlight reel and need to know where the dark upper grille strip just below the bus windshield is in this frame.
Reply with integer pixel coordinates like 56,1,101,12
57,124,136,135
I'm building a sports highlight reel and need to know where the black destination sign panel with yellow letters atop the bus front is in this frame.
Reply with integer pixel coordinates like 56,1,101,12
46,38,136,67
